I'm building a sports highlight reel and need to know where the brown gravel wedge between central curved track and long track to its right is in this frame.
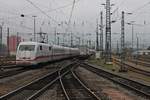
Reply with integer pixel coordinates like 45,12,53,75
76,67,144,100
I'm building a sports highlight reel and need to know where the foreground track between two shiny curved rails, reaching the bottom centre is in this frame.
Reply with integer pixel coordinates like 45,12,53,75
59,67,101,100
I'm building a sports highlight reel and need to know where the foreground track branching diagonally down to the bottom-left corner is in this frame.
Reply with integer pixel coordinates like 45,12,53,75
0,62,74,100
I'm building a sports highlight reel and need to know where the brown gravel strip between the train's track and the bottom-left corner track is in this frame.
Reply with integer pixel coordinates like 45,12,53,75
0,65,56,96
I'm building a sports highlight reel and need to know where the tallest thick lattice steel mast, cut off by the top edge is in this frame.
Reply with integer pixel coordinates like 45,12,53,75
105,0,112,64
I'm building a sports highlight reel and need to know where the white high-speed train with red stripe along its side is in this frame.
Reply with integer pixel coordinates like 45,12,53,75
16,42,80,66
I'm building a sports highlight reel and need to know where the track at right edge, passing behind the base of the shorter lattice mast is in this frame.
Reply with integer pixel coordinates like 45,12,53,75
115,59,150,76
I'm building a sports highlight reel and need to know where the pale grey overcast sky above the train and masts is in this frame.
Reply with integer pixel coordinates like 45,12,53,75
0,0,150,44
